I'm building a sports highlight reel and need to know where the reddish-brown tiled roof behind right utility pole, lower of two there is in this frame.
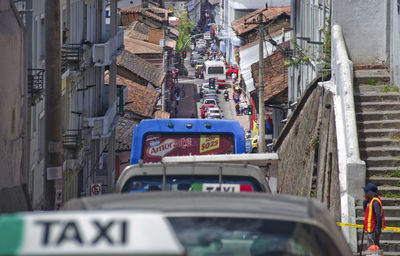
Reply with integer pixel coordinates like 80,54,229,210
251,47,288,104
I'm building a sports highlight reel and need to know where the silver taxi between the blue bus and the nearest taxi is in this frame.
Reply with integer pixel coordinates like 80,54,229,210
115,162,271,193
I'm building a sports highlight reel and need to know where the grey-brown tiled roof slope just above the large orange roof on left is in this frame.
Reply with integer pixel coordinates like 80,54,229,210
117,50,165,88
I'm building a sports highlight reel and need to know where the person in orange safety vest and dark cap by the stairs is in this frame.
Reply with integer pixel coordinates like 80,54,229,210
363,183,386,248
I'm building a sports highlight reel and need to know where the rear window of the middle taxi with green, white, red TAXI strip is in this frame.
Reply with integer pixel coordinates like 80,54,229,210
122,175,262,192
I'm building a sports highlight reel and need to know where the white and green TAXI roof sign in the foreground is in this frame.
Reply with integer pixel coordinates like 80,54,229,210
0,211,184,256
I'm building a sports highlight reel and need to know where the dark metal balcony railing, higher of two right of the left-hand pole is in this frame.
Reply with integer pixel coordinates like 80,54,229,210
61,44,84,72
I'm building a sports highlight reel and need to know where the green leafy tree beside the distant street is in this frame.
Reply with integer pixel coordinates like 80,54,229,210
176,10,195,54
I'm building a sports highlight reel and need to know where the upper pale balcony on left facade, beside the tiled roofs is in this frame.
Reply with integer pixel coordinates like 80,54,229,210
92,29,124,67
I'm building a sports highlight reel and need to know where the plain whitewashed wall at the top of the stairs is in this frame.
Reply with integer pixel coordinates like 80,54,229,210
332,0,389,65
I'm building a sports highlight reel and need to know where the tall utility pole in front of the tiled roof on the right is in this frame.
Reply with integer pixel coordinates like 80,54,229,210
258,15,265,153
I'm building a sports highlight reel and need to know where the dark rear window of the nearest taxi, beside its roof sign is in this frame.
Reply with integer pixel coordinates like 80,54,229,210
168,216,340,256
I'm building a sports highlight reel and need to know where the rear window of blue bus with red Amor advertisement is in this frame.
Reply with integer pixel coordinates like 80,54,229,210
142,133,235,163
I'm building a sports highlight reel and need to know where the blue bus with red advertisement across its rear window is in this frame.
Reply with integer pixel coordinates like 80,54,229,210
130,118,245,164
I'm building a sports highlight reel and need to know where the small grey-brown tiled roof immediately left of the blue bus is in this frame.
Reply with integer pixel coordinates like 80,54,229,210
115,116,140,151
